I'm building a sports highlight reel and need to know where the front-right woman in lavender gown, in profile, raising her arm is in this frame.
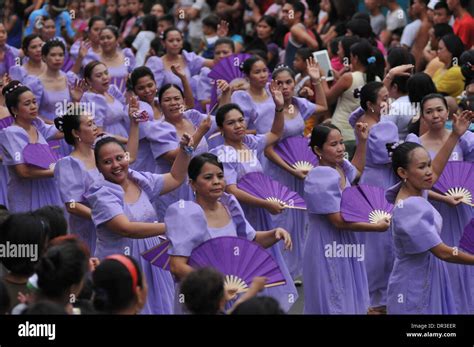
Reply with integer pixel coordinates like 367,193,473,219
386,109,474,314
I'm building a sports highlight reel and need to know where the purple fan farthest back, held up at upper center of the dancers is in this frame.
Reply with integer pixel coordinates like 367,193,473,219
208,53,251,106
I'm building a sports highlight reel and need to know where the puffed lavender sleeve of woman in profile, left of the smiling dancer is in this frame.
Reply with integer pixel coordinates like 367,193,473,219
54,156,86,203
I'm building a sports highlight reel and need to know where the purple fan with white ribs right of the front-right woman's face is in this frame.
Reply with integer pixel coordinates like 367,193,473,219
433,161,474,206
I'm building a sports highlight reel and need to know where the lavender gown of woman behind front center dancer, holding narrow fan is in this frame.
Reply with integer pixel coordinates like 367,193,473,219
211,135,298,311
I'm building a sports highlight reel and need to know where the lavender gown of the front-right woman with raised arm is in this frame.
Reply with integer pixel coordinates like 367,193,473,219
386,183,457,314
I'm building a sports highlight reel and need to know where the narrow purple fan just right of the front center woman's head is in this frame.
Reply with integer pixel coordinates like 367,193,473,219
237,172,306,210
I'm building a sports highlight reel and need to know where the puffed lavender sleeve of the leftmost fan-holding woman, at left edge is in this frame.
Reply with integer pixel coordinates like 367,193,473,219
0,127,29,166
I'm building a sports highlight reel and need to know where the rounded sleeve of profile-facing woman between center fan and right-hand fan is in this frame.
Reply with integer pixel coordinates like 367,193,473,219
304,166,342,214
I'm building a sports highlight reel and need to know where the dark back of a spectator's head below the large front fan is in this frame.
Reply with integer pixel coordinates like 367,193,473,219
181,267,224,314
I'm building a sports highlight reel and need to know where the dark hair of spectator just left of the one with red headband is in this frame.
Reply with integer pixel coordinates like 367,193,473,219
36,242,89,299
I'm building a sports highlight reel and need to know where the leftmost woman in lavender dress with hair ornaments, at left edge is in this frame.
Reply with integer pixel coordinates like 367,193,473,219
0,81,63,212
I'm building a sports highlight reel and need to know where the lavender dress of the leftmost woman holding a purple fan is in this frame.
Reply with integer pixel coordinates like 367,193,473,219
0,118,63,212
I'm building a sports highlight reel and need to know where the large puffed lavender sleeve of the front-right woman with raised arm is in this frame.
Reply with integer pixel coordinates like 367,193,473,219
392,197,442,254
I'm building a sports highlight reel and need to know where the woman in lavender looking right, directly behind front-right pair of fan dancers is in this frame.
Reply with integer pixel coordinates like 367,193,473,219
349,82,398,314
